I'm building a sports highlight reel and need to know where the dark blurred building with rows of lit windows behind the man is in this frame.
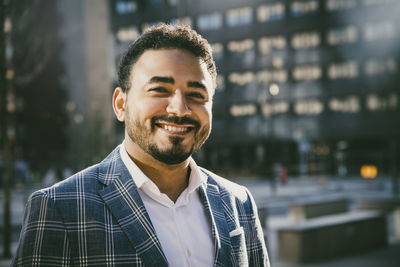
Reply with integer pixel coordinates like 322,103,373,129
109,0,400,176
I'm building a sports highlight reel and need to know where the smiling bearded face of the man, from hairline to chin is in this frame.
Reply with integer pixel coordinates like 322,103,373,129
125,49,214,164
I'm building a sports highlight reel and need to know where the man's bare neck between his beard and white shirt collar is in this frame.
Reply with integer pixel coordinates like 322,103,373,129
125,140,190,202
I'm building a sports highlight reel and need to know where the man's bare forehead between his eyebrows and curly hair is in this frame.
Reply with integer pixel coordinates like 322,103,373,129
131,49,212,88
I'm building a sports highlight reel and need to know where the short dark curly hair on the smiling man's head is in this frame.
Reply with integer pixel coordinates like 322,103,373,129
118,23,217,91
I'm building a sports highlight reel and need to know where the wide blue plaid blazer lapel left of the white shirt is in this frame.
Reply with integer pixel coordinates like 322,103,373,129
99,150,168,267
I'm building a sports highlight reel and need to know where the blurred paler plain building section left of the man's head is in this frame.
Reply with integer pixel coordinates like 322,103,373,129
58,0,116,170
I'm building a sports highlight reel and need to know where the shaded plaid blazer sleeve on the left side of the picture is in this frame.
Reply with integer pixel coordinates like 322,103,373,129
13,191,72,266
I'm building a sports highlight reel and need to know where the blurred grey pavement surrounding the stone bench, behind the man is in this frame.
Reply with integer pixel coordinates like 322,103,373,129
0,177,400,267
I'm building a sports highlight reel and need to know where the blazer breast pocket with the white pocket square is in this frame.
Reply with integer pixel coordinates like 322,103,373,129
229,227,249,267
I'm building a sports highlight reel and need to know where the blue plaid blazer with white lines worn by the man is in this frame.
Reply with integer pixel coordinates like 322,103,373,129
13,148,269,267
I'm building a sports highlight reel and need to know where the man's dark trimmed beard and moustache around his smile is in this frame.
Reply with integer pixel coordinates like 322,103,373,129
125,109,210,165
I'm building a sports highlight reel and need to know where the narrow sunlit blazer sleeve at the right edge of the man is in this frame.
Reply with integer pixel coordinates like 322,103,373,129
246,189,271,267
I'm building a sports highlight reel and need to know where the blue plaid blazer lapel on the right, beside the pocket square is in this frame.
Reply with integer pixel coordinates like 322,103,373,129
199,181,231,266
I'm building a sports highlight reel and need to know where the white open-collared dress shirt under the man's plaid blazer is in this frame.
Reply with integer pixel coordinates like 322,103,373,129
120,142,215,267
